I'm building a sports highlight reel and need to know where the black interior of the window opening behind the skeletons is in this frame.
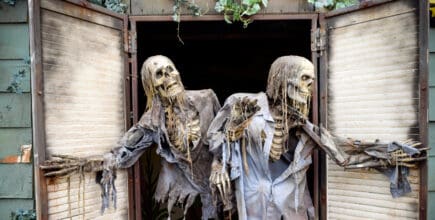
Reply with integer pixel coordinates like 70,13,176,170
137,20,313,218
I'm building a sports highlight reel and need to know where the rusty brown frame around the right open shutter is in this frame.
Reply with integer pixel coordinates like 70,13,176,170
319,0,429,220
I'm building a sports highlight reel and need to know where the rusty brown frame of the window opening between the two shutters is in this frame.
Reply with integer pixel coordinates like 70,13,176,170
129,13,321,220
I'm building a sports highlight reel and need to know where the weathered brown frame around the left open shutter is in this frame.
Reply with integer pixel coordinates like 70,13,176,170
28,0,133,220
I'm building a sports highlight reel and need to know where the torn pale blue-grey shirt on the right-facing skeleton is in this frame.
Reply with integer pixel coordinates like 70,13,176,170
208,93,314,220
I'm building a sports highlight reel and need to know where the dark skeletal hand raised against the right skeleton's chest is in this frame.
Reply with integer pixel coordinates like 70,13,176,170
226,96,261,141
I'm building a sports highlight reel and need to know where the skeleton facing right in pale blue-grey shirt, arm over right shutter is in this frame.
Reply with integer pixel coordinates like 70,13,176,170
208,56,424,219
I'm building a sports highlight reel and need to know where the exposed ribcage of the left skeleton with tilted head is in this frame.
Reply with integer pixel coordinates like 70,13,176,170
165,106,201,155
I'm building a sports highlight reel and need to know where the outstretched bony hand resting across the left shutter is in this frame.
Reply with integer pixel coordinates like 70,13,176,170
40,155,103,177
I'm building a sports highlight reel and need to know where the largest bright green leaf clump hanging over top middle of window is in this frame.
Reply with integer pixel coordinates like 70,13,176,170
215,0,268,28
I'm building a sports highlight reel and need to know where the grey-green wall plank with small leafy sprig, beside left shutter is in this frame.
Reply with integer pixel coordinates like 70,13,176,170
0,60,30,92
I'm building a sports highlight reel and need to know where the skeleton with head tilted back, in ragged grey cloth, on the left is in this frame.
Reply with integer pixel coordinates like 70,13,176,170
44,55,220,219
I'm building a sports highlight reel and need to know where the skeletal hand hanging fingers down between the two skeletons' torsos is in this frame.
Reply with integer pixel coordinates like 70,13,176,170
209,160,231,207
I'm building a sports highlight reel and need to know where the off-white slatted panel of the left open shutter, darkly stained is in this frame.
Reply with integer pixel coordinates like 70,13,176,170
41,1,129,219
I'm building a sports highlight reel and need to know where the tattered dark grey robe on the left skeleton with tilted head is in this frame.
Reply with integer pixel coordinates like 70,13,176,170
114,89,220,219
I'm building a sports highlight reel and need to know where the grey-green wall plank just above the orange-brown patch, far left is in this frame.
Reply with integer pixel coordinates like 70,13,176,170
0,128,32,159
